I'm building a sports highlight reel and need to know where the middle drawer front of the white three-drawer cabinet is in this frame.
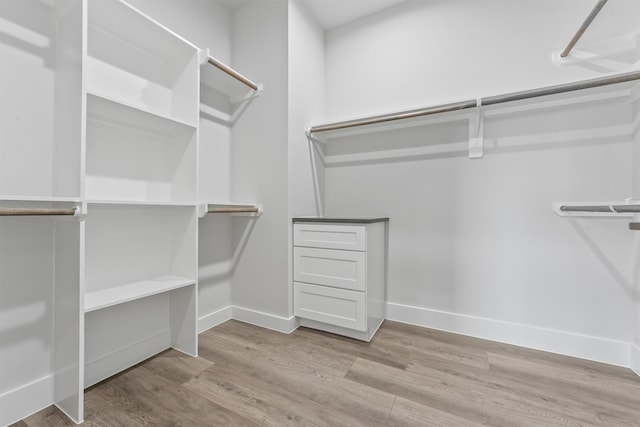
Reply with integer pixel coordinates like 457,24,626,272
293,246,366,291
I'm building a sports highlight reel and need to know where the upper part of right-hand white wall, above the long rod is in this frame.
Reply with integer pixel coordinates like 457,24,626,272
326,0,640,121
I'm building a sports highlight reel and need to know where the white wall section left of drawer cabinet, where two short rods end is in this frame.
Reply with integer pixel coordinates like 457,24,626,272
231,0,289,329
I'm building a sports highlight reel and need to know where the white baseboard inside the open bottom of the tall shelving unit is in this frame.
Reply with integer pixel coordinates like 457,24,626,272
84,330,171,388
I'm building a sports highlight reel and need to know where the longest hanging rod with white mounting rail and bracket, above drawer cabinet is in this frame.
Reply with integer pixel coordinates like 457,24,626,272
306,70,640,160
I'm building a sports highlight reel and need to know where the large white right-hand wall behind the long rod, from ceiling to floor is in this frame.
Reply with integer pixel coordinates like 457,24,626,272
325,0,640,366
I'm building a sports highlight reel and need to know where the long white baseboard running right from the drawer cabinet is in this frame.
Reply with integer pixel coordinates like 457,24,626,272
387,303,631,368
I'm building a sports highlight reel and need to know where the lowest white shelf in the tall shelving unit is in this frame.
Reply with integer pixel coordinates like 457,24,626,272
84,276,195,313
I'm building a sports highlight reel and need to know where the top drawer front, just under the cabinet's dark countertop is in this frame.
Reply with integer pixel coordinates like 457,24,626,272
293,223,367,251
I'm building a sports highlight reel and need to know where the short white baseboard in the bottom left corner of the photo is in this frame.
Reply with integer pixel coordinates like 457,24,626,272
0,375,54,426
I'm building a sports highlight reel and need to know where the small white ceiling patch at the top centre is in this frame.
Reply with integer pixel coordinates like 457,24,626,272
303,0,406,30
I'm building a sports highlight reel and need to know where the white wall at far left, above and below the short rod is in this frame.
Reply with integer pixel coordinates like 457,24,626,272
0,1,56,424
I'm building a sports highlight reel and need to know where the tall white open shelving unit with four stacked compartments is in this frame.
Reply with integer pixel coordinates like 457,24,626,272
84,0,199,398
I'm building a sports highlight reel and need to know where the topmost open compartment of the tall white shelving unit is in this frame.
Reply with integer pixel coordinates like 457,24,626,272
86,0,198,123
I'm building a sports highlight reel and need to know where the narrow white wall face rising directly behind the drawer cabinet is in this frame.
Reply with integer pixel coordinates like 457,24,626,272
288,0,325,316
